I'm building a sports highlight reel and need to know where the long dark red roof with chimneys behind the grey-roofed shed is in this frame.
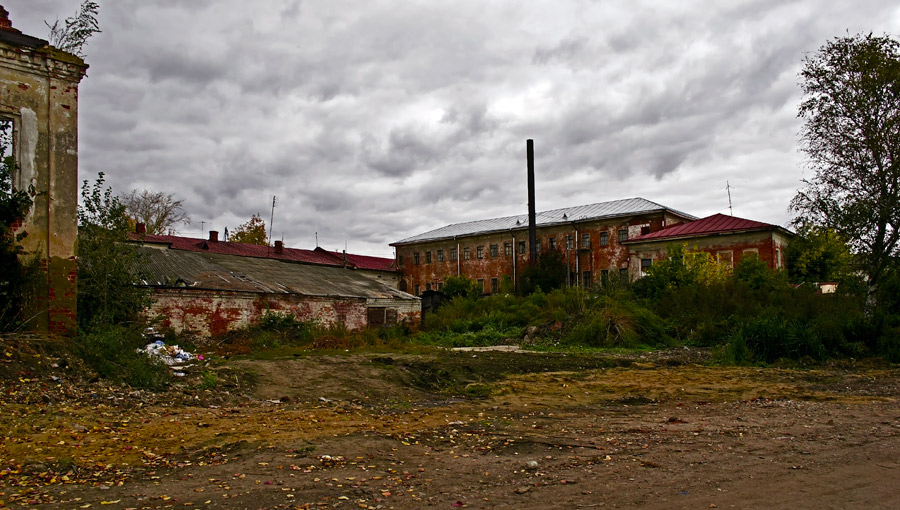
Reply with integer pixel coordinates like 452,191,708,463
130,234,396,271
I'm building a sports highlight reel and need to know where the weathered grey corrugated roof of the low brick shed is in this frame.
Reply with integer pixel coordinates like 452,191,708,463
138,246,418,300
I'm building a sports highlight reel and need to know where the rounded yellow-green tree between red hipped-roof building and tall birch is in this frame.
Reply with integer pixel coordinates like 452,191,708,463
787,225,853,283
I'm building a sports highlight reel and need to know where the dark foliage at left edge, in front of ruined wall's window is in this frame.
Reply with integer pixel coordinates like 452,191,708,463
0,122,39,331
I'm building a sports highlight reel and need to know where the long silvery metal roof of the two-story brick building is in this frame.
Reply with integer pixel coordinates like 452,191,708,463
391,197,696,246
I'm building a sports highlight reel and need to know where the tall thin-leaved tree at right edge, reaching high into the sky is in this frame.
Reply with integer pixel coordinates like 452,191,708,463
791,34,900,308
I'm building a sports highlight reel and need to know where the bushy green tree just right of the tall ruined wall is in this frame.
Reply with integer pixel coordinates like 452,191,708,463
78,172,150,331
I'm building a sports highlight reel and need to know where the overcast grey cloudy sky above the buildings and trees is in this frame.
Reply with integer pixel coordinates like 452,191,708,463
7,0,900,257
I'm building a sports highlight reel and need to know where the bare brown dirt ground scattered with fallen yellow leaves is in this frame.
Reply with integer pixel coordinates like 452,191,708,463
0,342,900,509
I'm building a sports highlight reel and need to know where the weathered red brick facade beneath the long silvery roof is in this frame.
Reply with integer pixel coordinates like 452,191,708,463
397,213,675,294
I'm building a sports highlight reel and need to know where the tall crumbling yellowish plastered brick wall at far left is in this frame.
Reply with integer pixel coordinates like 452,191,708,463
0,28,87,332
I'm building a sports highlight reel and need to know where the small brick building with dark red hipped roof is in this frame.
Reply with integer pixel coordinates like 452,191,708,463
624,214,794,273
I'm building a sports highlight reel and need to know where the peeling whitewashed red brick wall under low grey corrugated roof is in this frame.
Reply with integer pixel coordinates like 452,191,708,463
146,288,366,337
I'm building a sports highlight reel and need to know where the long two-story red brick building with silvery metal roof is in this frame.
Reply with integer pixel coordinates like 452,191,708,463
391,198,696,295
